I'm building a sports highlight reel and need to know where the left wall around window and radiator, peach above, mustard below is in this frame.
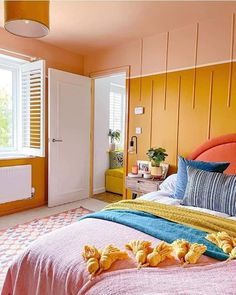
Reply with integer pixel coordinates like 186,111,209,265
0,29,83,216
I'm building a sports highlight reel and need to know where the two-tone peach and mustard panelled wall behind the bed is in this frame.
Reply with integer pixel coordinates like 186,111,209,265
85,14,236,176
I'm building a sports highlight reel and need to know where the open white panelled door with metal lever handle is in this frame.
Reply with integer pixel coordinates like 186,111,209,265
48,69,91,207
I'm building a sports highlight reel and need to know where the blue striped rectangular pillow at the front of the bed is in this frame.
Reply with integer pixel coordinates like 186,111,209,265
182,166,236,216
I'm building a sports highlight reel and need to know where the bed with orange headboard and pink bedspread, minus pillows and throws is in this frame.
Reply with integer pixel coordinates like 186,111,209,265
2,134,236,295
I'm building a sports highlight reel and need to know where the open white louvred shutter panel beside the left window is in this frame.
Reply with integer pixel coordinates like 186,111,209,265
20,60,45,157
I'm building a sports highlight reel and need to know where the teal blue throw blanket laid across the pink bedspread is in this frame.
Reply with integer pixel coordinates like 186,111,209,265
80,210,229,260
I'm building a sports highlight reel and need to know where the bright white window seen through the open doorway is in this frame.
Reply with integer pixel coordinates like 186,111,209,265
109,83,125,148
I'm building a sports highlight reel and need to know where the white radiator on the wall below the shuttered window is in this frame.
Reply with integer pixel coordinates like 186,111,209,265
0,165,32,204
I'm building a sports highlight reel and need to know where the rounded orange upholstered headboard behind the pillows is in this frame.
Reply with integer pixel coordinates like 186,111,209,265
187,133,236,174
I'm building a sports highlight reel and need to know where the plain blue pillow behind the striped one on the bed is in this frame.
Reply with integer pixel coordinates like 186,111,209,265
173,156,230,200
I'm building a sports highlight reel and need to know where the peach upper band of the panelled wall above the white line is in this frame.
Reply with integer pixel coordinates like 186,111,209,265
84,17,236,77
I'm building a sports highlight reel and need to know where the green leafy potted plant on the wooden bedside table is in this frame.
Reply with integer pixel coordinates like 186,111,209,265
147,148,168,178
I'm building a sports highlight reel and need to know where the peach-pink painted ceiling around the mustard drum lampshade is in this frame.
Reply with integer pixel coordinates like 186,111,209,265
0,0,236,54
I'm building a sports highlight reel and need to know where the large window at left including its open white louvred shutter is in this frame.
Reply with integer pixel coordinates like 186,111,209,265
0,55,45,158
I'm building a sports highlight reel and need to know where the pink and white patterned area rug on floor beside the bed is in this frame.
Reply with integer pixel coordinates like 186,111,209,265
0,207,92,293
